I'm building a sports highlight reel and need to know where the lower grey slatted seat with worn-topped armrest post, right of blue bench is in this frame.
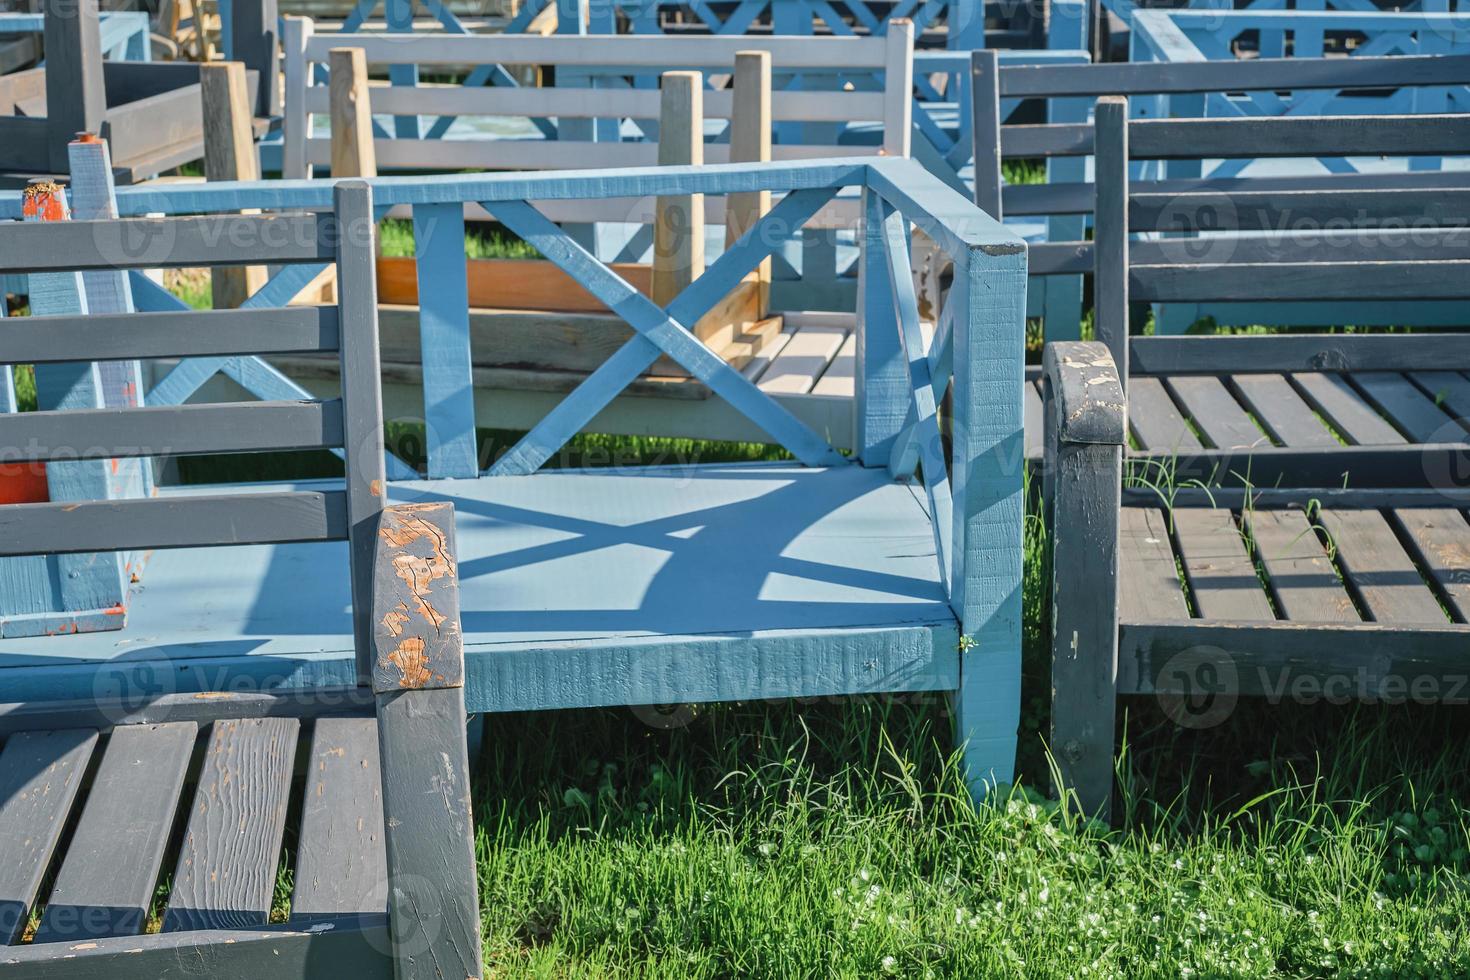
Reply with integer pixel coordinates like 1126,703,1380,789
1042,343,1470,813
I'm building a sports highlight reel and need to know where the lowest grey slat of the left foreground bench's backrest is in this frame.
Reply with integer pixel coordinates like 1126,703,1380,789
0,491,347,555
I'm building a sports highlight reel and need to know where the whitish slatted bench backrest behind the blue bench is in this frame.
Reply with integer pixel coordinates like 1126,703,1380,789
282,25,913,176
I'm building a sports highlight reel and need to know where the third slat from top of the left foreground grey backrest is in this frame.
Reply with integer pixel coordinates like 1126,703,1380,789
0,398,343,460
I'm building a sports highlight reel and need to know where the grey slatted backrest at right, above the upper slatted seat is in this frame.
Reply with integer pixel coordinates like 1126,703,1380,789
1094,98,1470,379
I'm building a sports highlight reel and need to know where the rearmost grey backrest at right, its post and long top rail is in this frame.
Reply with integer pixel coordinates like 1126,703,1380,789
970,51,1470,216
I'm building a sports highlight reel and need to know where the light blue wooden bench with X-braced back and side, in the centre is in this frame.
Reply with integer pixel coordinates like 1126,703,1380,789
0,157,1025,790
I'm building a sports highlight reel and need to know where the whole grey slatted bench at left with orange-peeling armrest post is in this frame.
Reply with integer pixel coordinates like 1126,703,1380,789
0,182,481,980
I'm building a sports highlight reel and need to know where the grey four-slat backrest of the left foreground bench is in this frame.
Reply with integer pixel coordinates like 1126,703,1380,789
0,182,385,677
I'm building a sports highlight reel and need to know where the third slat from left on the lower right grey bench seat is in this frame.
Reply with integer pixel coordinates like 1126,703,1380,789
1247,510,1361,623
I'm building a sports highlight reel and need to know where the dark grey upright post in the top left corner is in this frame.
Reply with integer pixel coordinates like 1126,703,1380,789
46,0,107,173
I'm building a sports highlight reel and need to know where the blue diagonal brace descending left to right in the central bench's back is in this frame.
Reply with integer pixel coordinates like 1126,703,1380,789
484,192,845,475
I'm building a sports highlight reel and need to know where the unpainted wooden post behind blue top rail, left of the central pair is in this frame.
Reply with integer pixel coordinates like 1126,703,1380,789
651,72,704,308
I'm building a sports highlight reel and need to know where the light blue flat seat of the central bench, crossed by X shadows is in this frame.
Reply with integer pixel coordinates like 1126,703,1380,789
0,464,958,711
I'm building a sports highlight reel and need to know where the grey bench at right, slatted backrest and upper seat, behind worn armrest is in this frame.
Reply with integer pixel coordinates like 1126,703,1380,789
1081,98,1470,486
